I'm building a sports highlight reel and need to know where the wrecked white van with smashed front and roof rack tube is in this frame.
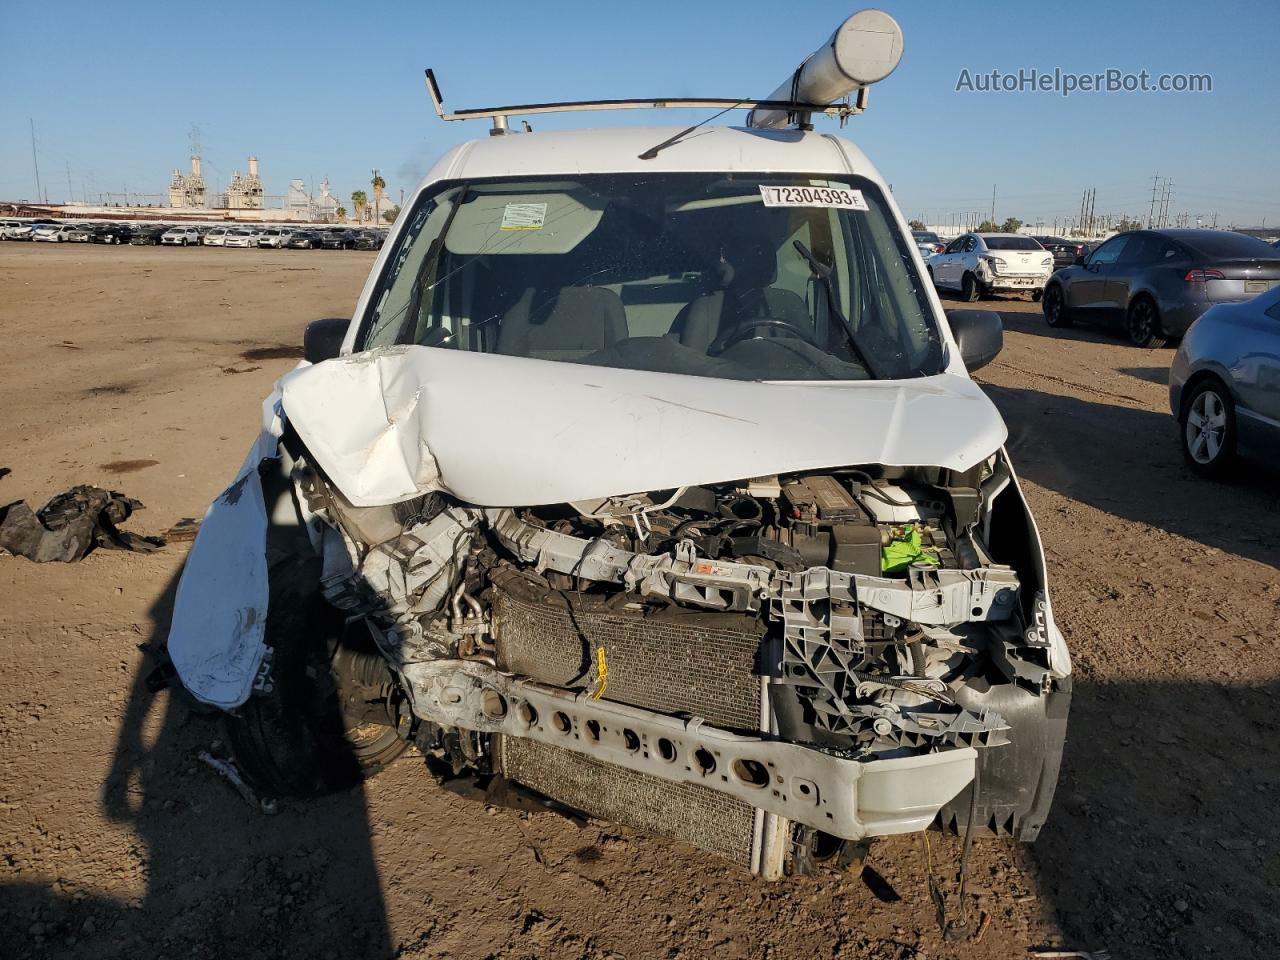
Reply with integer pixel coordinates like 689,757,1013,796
168,12,1071,878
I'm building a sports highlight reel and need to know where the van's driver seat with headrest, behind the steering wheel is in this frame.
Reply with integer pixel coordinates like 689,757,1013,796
671,239,813,353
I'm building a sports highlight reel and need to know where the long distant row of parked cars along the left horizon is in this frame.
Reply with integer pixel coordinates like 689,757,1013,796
0,220,387,250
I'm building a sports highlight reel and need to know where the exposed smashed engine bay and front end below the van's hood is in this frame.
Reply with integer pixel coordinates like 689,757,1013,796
287,451,1069,877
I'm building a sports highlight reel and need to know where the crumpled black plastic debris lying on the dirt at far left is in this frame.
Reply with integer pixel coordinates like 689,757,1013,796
0,485,165,563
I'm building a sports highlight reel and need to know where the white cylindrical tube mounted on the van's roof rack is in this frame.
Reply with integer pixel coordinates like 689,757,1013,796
746,10,902,127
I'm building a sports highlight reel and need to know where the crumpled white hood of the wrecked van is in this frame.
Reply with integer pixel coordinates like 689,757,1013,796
280,347,1007,507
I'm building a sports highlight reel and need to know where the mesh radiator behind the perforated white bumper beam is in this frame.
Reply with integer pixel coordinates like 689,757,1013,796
492,571,763,869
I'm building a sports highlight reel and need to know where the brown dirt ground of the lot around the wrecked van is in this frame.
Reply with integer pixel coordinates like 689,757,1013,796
0,243,1280,960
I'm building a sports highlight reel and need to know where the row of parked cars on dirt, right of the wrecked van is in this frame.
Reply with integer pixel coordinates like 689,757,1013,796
913,229,1280,476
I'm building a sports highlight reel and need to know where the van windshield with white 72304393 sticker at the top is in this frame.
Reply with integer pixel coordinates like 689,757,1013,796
361,174,943,380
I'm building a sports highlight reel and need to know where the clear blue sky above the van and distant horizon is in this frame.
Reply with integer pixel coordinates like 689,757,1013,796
0,0,1280,224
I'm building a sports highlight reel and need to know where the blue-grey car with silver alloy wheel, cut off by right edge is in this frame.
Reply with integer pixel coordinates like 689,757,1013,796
1169,287,1280,476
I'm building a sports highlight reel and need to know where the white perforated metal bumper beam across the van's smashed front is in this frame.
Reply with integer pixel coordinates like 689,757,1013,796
403,660,978,840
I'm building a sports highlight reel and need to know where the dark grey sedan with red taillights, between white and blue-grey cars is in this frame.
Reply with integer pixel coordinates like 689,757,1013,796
1043,230,1280,347
